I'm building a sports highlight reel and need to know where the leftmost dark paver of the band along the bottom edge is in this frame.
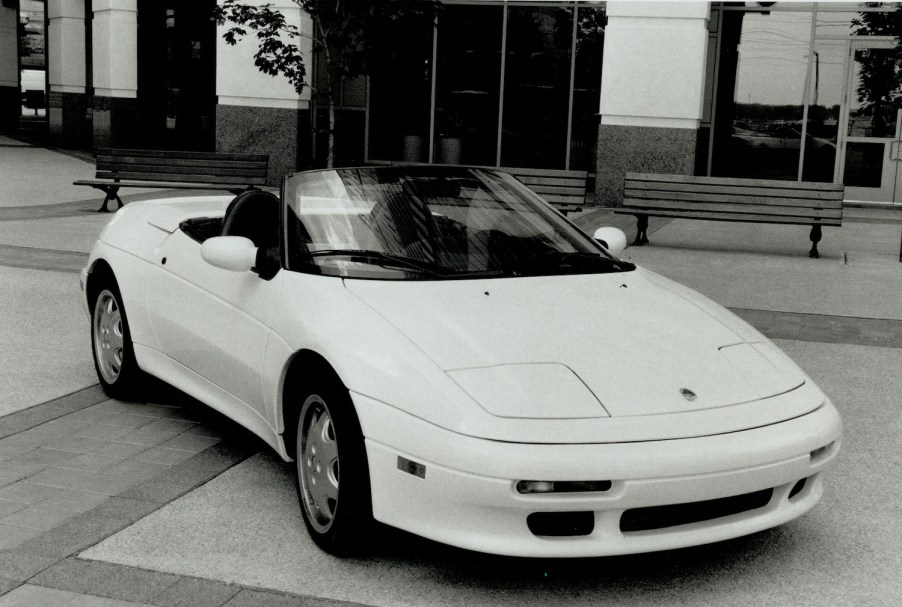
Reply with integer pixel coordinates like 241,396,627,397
31,558,179,603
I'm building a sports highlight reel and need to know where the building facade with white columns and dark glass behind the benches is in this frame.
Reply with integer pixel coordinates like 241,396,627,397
0,0,902,206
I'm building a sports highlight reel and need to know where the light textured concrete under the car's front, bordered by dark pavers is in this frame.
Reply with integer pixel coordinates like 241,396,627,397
82,341,902,607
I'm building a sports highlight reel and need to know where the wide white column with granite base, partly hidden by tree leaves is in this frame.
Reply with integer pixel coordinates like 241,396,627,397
216,0,313,185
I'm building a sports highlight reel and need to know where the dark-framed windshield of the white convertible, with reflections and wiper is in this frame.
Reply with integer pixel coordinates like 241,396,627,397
282,167,634,280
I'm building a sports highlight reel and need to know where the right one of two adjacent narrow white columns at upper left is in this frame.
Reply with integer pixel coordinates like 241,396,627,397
92,0,138,147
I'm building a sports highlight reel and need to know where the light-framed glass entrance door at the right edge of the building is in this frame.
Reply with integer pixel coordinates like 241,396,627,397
840,40,902,204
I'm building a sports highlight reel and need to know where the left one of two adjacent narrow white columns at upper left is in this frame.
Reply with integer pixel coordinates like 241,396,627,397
47,0,91,147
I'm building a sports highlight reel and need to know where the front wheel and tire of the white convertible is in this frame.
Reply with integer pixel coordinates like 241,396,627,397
295,380,373,556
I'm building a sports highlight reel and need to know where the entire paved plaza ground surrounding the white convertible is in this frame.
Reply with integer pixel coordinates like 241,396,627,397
0,137,902,607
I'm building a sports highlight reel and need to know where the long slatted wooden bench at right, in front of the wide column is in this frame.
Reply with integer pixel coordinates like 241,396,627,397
614,173,843,257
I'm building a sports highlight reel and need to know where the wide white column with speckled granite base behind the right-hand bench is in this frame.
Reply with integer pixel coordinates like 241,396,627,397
595,0,709,206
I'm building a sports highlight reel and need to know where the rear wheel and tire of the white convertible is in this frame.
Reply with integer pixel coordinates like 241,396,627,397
91,276,145,400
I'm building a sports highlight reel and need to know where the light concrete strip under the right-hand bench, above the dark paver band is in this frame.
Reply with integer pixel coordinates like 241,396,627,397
623,219,902,320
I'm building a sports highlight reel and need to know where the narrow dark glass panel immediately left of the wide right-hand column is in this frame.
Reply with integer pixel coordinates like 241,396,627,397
570,6,606,171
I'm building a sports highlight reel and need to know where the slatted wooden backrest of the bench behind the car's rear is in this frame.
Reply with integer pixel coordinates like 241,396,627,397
97,148,269,185
